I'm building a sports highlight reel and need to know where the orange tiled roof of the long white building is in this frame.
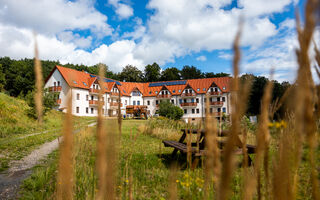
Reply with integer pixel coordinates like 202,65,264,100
46,66,231,97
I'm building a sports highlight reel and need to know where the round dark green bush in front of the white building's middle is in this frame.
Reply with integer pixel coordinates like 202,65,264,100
158,100,183,120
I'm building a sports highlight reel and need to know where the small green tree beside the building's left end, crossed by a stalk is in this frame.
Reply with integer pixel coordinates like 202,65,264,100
25,89,59,119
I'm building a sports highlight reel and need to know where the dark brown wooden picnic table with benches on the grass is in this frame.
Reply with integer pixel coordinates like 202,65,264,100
162,129,256,168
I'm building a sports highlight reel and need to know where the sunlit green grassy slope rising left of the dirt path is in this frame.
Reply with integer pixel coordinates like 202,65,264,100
0,93,93,171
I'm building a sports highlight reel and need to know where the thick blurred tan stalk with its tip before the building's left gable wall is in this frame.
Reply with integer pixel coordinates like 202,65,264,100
57,89,73,200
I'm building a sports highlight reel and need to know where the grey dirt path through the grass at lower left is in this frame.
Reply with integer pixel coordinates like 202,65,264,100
0,123,96,200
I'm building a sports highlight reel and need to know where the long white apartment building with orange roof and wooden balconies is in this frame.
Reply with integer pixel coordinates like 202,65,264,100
45,66,231,120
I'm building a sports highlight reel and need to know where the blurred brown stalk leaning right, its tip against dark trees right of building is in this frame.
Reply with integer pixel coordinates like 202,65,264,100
244,78,273,199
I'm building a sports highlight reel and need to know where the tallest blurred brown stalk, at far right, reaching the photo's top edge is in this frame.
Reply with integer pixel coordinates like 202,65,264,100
294,0,320,199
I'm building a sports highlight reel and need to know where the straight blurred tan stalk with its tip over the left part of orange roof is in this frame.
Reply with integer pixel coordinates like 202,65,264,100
96,65,107,200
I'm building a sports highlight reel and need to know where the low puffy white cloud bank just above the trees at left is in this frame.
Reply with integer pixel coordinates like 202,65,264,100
0,24,146,72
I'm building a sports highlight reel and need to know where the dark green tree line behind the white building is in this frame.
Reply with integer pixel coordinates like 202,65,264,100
0,57,290,115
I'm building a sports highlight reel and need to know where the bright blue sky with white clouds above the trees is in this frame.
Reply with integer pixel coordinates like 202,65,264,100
0,0,319,81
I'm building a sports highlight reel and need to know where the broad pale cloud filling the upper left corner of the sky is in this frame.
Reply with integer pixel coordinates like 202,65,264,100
0,0,112,37
